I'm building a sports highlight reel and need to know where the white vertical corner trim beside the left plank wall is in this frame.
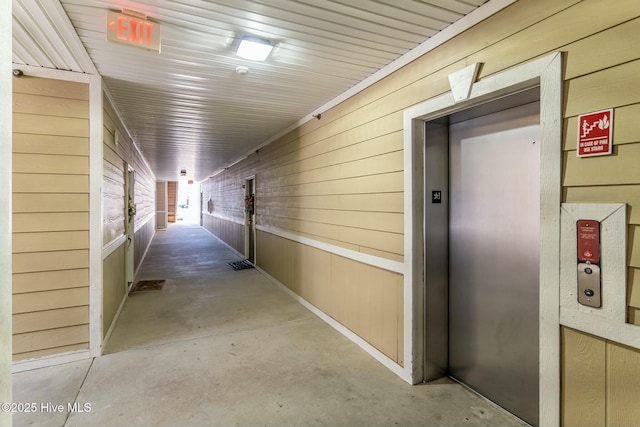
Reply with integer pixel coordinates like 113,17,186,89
89,75,104,356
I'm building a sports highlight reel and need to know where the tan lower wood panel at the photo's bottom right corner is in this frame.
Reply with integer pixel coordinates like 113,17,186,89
606,342,640,427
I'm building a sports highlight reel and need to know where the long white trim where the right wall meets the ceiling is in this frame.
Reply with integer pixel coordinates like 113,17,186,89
209,0,517,178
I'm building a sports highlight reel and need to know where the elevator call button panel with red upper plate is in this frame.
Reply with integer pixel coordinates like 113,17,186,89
576,220,602,308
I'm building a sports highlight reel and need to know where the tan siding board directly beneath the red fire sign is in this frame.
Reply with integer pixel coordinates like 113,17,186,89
562,144,640,187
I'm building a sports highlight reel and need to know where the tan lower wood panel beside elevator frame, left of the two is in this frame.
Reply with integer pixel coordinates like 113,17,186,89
561,327,607,427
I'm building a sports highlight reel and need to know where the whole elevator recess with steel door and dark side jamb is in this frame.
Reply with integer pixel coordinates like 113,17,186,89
424,88,540,426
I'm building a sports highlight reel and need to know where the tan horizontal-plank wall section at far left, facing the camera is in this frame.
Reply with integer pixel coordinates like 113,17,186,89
13,77,89,360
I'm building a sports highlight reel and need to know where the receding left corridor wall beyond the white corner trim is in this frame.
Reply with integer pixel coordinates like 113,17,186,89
102,96,156,336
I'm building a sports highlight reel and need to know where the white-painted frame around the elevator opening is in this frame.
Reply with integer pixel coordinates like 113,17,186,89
404,53,562,425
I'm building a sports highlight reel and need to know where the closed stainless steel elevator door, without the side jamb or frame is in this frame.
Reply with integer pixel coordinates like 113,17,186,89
449,102,540,425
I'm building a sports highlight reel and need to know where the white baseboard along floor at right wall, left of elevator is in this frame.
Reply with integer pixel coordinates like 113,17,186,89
255,266,411,383
